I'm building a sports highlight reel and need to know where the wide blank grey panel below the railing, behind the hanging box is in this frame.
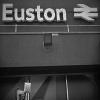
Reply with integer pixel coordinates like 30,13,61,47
0,34,100,67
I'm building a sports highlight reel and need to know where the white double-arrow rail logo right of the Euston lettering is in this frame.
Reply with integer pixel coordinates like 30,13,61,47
74,4,98,22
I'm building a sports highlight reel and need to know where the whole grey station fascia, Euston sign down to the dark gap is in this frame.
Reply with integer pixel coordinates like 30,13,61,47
0,0,100,67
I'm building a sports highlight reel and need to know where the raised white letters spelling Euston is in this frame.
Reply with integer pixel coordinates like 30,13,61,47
2,4,70,22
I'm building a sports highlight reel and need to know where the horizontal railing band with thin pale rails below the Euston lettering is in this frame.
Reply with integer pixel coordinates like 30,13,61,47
0,24,100,35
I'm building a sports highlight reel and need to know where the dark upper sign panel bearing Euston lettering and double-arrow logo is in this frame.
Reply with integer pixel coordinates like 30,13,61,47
0,0,100,25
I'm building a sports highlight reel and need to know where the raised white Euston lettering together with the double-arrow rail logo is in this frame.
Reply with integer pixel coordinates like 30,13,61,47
2,4,98,22
